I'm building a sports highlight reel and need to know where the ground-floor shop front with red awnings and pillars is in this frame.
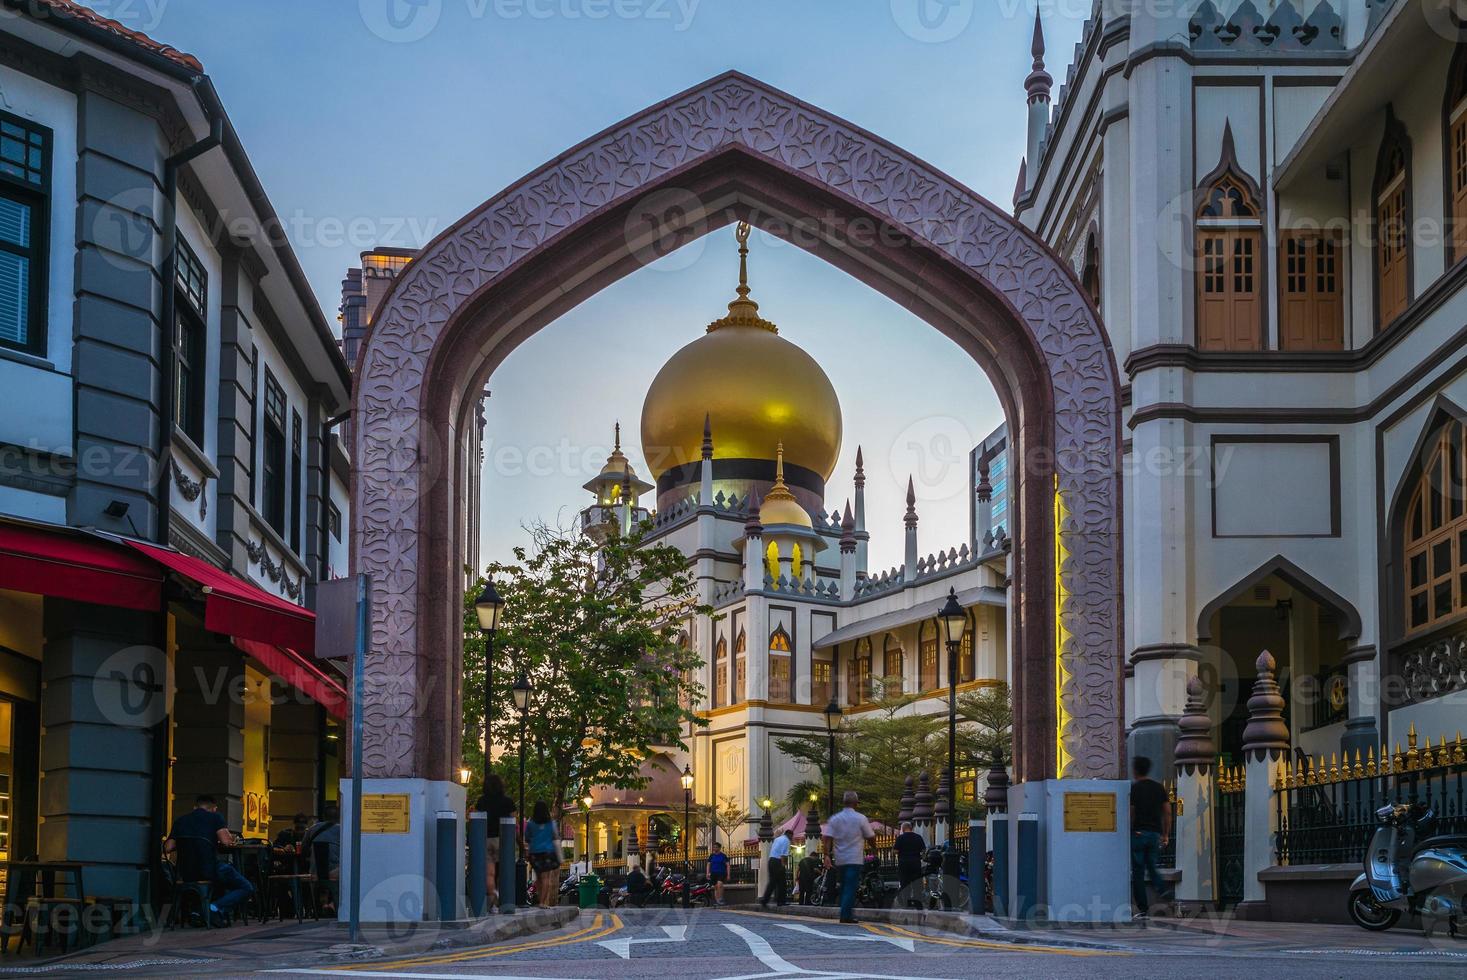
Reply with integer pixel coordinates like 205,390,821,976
0,519,348,902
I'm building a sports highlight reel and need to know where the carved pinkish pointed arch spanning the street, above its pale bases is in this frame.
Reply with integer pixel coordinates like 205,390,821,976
352,73,1122,780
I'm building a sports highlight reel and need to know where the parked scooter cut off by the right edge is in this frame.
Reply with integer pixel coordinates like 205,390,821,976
1350,802,1467,936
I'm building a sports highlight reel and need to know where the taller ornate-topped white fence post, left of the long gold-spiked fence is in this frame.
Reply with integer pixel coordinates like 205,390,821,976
1238,650,1289,918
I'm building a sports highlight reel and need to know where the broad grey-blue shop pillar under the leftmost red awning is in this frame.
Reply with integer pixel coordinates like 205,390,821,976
39,599,167,901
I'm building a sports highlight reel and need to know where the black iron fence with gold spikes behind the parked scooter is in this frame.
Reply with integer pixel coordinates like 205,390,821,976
1273,726,1467,864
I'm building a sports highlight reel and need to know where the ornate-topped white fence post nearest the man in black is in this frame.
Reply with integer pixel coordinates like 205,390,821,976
1172,675,1218,917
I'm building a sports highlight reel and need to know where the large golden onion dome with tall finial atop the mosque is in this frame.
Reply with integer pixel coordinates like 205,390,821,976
641,224,841,480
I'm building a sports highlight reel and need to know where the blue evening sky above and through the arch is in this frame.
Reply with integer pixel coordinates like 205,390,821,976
111,0,1090,568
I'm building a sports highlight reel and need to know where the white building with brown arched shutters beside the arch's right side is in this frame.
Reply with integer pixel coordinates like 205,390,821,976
1014,0,1467,772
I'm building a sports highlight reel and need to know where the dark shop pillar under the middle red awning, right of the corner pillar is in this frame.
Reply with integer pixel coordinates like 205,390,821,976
173,624,245,830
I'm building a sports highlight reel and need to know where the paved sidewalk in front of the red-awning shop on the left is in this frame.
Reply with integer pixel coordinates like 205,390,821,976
0,907,579,977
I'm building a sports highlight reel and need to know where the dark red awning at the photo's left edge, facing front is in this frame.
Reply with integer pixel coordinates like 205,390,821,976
0,524,163,612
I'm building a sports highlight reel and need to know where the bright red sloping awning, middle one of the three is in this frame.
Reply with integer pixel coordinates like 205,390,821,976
128,541,315,653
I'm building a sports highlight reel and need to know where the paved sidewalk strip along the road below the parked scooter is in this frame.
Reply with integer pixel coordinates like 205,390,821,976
739,905,1467,961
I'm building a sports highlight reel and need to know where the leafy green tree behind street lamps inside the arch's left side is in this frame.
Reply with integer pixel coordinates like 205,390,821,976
464,524,710,808
